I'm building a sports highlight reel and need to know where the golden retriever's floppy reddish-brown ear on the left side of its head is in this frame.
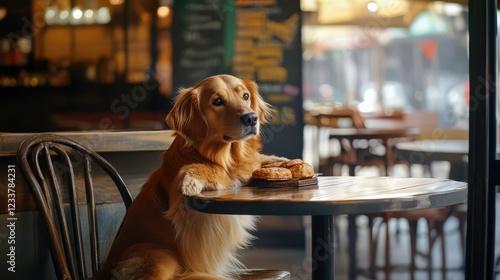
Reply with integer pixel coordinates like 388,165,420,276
166,88,207,144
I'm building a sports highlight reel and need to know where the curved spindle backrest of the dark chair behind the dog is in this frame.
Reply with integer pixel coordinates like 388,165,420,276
17,133,132,279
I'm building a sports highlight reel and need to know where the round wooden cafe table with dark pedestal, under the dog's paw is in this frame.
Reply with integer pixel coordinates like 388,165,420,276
185,176,467,280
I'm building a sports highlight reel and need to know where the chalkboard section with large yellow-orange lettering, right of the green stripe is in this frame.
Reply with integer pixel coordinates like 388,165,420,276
231,0,304,158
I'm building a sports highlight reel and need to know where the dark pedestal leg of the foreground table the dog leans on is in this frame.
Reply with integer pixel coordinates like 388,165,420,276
311,215,335,280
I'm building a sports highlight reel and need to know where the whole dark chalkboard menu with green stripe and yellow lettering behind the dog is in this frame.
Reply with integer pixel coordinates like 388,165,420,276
172,0,303,158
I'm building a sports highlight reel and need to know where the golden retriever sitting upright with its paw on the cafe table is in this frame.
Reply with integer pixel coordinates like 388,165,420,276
96,75,287,280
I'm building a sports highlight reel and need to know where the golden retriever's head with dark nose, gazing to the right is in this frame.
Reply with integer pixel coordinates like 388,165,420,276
166,75,271,143
